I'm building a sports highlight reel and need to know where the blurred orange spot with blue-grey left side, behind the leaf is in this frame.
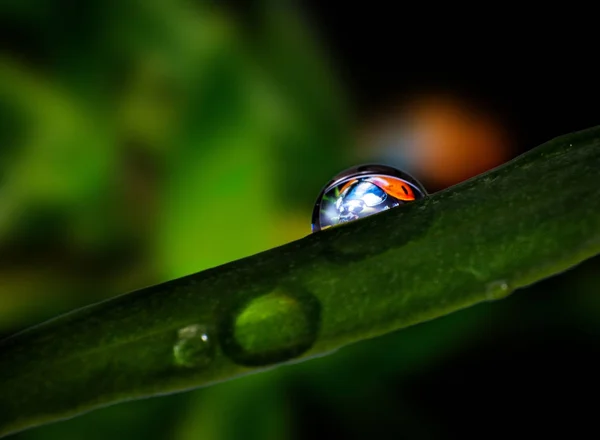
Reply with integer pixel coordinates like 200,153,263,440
360,95,511,188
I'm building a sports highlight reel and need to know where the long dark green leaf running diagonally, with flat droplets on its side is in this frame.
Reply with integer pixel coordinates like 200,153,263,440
0,127,600,434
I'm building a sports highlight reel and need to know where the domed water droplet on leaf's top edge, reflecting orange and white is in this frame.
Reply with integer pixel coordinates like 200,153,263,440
312,165,427,232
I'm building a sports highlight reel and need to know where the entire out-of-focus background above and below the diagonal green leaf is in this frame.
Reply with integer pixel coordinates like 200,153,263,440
0,0,600,440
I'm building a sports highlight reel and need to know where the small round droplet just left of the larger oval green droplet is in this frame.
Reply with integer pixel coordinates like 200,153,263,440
173,324,215,367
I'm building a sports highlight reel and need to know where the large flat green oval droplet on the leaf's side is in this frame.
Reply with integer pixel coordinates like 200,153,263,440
220,286,321,366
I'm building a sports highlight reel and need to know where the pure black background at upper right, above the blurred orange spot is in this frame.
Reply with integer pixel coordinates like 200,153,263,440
304,1,600,151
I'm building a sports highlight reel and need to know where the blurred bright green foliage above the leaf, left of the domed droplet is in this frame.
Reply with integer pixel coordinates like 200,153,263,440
0,1,349,331
